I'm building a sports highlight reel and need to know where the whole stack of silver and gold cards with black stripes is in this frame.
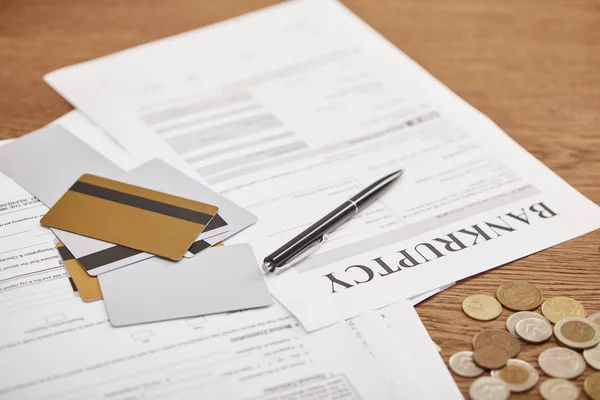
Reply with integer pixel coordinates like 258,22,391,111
0,125,272,326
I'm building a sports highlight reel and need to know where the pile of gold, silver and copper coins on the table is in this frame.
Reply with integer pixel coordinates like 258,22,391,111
449,281,600,400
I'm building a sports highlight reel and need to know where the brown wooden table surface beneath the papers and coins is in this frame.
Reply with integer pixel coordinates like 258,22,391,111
0,0,600,398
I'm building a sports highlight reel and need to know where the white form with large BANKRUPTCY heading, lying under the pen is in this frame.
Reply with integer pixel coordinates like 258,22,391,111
46,0,600,330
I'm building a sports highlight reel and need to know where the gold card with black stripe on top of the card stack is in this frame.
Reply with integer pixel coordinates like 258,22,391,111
40,174,219,260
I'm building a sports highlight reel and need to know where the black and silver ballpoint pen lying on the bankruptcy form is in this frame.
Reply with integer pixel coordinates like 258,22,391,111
262,170,404,273
